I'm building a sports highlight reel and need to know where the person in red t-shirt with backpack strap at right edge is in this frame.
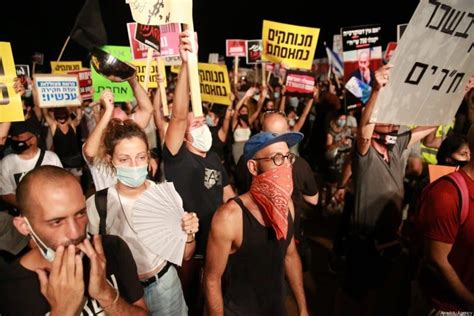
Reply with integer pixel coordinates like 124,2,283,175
418,125,474,315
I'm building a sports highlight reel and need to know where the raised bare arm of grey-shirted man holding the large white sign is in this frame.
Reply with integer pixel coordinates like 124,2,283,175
357,65,393,156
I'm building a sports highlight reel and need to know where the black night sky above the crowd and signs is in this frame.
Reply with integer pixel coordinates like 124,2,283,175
0,0,418,72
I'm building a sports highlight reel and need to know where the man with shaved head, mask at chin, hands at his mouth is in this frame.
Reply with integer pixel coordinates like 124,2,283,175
0,166,146,315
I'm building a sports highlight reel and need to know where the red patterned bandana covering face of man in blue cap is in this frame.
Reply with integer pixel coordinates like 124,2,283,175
250,165,293,239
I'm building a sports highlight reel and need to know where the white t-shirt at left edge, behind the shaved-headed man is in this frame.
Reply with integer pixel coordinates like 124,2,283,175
0,150,63,195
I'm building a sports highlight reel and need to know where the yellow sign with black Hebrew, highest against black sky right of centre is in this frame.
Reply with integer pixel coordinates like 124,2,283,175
262,20,319,69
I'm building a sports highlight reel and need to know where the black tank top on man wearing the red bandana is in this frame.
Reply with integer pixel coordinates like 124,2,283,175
222,197,293,316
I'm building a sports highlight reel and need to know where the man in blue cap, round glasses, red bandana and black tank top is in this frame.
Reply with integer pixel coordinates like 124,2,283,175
204,132,308,316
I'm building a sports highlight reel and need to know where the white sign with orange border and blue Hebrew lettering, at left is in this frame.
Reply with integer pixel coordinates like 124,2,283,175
34,74,82,108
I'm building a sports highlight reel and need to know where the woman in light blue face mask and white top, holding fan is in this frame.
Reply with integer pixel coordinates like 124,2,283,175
87,120,198,315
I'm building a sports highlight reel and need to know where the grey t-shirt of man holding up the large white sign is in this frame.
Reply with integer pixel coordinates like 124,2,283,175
352,131,411,242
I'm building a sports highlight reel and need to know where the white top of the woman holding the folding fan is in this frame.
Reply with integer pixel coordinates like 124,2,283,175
86,180,165,275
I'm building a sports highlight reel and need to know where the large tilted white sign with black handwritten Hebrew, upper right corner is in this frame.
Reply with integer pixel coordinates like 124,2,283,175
371,0,474,126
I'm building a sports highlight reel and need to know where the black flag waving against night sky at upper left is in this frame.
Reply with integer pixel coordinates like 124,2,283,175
70,0,107,50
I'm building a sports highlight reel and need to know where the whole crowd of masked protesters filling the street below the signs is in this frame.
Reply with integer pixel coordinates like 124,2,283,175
0,29,474,315
